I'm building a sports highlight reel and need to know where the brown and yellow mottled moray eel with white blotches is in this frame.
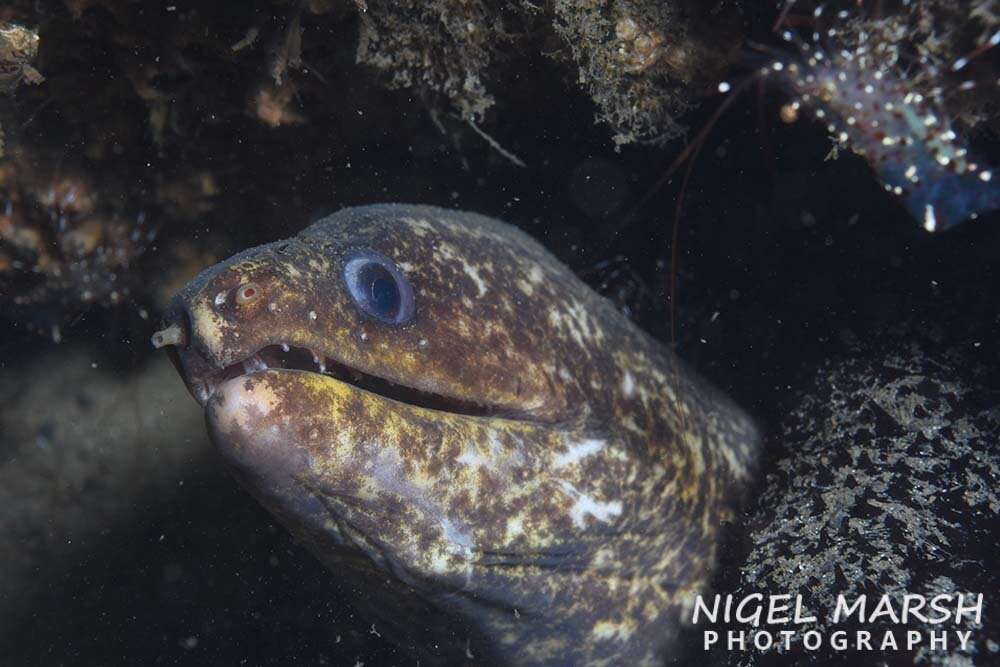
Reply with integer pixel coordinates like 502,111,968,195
153,205,758,665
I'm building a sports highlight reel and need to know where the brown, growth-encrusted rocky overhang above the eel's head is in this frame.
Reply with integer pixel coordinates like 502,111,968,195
0,0,998,338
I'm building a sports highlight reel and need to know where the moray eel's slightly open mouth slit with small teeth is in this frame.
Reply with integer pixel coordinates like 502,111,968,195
168,342,508,417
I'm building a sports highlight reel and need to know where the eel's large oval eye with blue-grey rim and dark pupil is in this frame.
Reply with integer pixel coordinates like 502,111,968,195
344,250,414,324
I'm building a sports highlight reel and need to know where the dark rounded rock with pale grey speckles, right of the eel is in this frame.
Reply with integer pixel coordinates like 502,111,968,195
725,336,1000,665
